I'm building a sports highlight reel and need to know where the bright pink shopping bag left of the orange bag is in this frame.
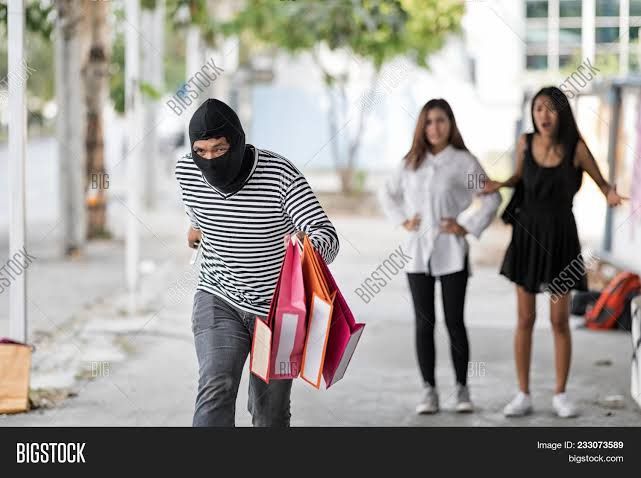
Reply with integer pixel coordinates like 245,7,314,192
250,238,306,383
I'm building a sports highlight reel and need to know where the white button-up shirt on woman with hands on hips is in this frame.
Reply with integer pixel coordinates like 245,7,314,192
379,145,501,276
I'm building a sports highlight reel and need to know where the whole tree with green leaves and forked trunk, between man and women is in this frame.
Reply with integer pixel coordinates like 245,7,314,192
218,0,464,192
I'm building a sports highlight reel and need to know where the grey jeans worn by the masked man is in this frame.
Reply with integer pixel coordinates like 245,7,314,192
192,290,292,427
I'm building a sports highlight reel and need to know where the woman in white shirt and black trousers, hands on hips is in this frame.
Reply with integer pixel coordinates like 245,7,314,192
380,99,500,413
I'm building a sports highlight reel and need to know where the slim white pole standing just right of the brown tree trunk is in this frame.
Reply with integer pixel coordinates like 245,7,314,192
125,0,142,314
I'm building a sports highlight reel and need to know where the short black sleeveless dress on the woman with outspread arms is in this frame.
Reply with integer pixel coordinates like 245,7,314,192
500,133,587,294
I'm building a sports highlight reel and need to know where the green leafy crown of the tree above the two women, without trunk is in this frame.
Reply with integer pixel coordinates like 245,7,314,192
220,0,464,69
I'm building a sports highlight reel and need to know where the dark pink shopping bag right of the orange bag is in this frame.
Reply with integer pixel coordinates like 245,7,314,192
316,252,365,388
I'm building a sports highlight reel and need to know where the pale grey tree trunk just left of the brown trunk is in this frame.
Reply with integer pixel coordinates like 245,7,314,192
56,0,89,256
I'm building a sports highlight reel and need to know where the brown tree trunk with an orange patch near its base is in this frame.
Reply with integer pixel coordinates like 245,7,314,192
83,2,110,239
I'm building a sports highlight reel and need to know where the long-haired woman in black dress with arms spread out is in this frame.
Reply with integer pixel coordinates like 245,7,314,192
484,87,626,417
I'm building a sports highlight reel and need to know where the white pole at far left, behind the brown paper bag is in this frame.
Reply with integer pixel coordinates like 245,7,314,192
7,0,27,342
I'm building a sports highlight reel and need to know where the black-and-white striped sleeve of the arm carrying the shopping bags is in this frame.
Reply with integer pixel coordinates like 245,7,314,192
283,173,340,264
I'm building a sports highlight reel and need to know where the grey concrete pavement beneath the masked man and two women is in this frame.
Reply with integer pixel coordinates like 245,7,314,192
0,217,641,426
